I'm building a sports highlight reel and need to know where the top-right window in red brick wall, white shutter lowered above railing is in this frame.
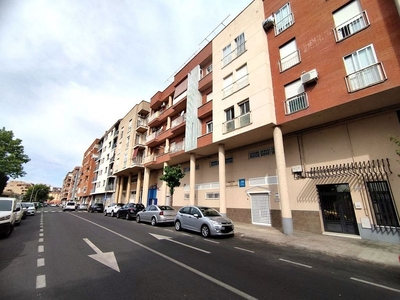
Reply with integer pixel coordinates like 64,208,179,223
333,1,369,42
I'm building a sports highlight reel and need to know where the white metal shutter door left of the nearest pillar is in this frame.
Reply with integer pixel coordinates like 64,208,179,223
250,193,271,225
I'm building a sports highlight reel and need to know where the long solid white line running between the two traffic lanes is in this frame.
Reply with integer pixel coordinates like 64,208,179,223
71,214,257,300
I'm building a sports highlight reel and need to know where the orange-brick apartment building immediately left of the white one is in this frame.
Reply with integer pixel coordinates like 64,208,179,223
76,139,99,203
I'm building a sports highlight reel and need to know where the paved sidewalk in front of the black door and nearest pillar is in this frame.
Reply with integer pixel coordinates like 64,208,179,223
235,222,400,269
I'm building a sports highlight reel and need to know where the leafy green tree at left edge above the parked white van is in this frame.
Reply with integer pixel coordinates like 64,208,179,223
0,127,30,195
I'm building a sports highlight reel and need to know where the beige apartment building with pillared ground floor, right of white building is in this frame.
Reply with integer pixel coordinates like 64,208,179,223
113,101,150,205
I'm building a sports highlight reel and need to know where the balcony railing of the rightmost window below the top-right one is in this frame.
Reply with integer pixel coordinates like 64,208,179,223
345,62,387,93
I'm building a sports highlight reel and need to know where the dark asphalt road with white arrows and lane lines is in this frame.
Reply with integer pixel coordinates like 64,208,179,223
0,207,400,300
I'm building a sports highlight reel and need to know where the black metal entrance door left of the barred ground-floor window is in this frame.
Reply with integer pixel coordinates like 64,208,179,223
317,184,359,235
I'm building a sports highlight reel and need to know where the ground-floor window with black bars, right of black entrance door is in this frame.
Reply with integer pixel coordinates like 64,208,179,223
367,181,399,227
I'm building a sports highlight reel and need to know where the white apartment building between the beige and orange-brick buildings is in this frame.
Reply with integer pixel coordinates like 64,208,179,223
88,119,121,204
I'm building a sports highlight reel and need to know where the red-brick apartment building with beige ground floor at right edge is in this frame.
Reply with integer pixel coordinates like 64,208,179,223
263,0,400,243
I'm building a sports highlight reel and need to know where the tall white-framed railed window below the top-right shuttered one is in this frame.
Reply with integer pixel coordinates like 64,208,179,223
344,45,386,92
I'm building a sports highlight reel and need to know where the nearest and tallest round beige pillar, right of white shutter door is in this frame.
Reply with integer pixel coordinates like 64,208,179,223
274,126,293,235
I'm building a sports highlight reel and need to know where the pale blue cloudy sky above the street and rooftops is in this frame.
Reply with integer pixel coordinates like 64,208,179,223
0,0,253,187
